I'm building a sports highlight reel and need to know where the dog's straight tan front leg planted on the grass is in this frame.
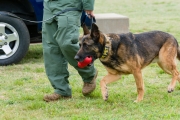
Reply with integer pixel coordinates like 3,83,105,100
133,69,144,102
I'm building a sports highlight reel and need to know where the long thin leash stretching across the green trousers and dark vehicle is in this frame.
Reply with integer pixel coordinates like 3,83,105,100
0,8,82,23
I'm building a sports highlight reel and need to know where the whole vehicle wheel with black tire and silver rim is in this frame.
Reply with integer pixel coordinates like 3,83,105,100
0,12,30,66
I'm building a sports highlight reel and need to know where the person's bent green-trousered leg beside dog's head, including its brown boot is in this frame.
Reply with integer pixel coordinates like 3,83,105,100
55,16,97,95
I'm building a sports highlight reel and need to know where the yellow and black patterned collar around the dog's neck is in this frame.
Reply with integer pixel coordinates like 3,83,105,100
100,34,110,59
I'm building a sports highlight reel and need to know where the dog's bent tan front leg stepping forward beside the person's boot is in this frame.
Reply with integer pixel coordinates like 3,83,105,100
100,74,121,101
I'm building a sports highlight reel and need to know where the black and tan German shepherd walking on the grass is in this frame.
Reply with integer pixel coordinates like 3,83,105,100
75,23,180,102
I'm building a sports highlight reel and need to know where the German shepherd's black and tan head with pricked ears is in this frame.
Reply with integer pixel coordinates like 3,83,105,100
74,23,105,63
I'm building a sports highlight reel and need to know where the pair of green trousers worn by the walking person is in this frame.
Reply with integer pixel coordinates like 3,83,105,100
42,1,96,96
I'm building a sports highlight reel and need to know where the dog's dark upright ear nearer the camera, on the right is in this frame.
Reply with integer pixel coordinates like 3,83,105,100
90,23,100,40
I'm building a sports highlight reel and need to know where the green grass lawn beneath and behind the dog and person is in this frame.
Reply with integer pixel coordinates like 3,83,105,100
0,0,180,120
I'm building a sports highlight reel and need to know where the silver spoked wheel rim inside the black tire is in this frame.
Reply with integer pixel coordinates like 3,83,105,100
0,22,19,59
